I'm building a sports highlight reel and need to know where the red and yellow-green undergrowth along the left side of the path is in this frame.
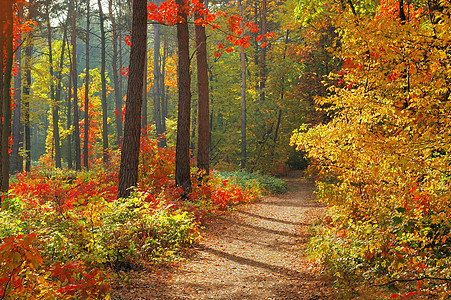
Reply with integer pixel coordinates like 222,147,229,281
0,128,281,299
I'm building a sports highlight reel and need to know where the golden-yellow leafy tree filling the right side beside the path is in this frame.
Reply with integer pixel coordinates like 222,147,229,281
292,1,451,290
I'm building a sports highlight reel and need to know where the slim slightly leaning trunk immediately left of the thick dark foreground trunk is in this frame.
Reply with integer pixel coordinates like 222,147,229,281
108,0,122,146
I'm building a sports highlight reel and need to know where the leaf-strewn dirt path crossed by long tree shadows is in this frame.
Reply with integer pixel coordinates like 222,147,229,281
112,174,330,300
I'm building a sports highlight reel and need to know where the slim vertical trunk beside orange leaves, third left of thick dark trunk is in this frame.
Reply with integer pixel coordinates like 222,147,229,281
83,0,91,170
